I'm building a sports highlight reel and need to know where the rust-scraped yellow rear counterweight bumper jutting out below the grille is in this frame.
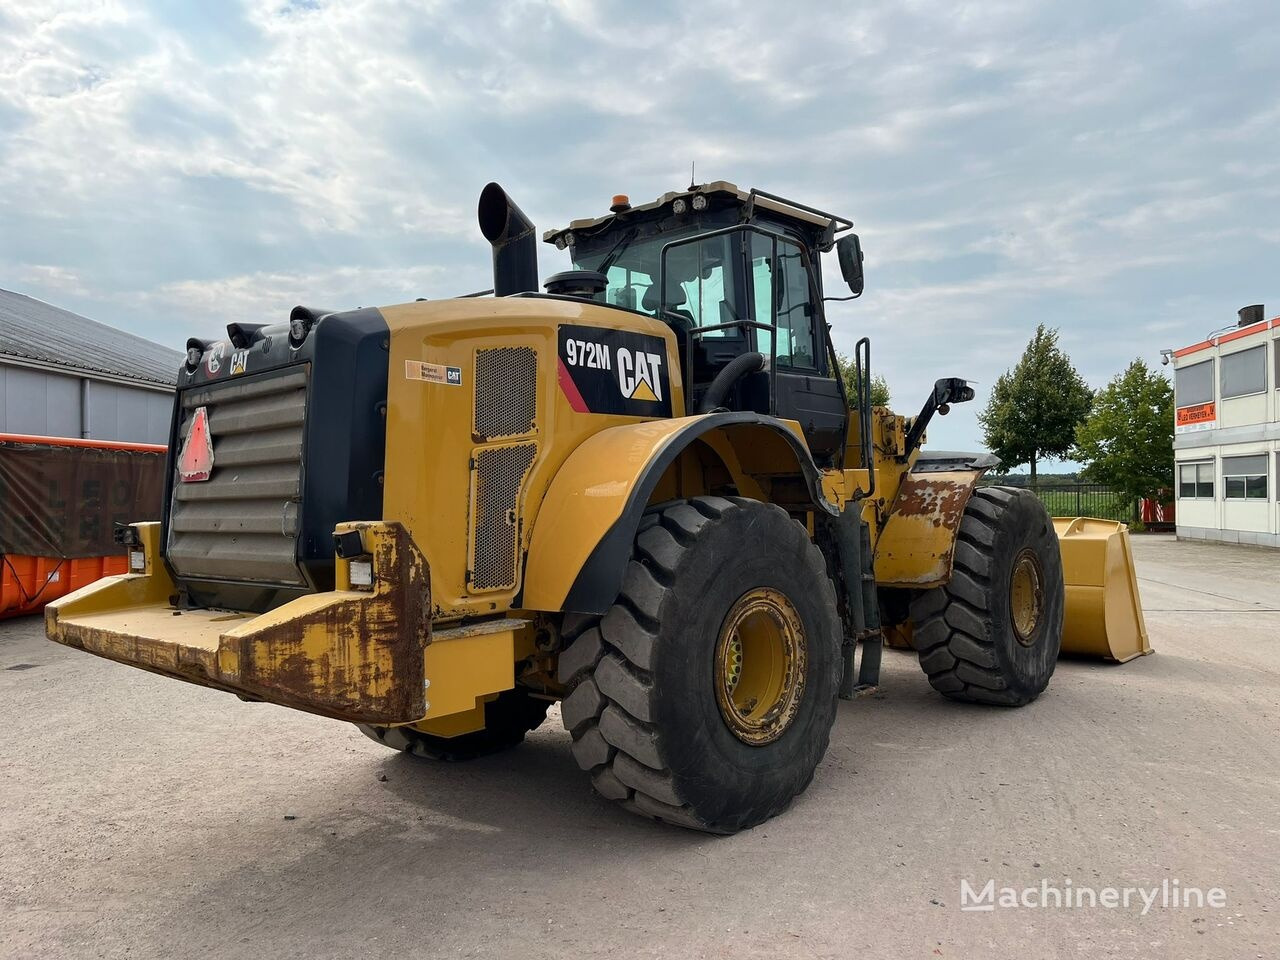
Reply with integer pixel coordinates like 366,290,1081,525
46,524,431,724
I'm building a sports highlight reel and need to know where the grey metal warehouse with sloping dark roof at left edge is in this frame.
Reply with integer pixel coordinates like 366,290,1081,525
0,289,183,443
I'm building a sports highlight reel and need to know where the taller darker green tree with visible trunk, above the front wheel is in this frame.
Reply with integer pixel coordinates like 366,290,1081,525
978,324,1093,484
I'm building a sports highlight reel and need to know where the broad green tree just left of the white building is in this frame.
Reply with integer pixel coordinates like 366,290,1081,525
1074,360,1174,499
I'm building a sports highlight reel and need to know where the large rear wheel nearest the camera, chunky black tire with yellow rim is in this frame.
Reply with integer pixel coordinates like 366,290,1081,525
559,497,841,833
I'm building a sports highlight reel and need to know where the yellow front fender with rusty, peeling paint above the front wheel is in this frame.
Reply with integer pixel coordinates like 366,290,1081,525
876,470,982,588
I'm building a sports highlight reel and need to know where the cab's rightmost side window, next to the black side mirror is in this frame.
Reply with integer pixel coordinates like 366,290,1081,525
751,233,818,370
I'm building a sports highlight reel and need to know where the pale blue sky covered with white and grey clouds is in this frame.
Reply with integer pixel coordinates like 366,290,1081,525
0,0,1280,447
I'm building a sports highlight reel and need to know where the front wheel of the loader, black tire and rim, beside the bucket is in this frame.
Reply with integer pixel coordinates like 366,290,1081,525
911,486,1064,707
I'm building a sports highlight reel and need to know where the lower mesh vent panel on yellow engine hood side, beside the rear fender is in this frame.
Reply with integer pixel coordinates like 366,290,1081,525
471,443,538,591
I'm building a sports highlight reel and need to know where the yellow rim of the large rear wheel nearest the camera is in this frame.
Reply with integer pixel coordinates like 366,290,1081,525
716,588,808,746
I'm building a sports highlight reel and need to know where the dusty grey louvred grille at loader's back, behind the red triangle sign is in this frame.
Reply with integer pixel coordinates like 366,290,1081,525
168,366,308,584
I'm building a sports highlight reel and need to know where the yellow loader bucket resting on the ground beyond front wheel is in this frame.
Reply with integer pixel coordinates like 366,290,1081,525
1053,517,1151,663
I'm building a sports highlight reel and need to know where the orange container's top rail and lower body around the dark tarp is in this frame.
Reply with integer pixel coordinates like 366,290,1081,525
0,434,166,620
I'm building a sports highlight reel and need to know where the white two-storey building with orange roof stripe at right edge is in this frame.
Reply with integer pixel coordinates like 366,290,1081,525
1171,305,1280,547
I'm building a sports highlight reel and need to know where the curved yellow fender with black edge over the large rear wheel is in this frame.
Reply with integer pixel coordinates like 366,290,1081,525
521,412,838,614
